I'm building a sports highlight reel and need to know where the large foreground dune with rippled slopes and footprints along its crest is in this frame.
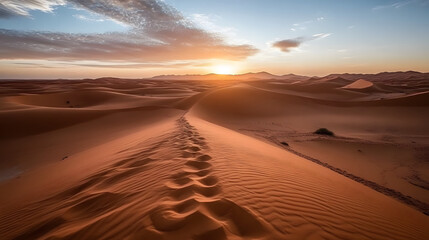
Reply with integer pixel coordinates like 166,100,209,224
0,117,429,239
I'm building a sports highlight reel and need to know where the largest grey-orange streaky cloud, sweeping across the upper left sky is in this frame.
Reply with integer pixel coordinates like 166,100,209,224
0,0,258,63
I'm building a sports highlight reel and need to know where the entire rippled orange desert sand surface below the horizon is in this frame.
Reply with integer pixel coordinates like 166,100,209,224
0,76,429,240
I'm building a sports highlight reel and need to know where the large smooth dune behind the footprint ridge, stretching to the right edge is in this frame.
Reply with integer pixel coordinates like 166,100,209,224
193,84,428,136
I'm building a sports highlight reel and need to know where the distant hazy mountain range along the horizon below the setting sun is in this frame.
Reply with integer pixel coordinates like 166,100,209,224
152,71,429,82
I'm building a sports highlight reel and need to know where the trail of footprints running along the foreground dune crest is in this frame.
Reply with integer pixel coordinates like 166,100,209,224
150,118,266,240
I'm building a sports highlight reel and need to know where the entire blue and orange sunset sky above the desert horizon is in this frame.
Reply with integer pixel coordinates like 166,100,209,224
0,0,429,79
